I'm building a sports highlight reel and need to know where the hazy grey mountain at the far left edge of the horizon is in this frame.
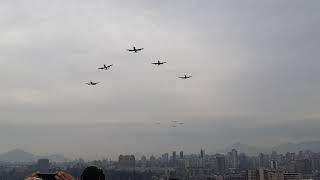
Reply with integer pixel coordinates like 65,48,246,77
0,149,37,162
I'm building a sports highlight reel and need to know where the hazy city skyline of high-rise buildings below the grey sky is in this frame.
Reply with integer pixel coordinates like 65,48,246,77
0,149,320,180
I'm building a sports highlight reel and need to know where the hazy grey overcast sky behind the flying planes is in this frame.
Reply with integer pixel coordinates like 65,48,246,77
0,0,320,158
